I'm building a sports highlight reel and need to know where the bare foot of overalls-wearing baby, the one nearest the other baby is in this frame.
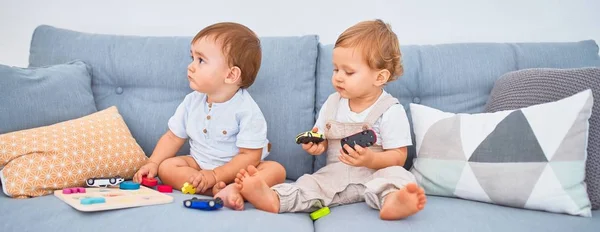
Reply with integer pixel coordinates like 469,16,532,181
235,165,279,213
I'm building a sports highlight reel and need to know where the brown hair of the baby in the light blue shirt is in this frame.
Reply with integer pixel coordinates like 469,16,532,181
192,22,262,88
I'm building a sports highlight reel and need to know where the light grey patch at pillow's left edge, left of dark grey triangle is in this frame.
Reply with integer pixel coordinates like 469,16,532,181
419,116,466,160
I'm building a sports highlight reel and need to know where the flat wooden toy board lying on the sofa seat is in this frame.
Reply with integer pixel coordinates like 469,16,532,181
54,185,173,212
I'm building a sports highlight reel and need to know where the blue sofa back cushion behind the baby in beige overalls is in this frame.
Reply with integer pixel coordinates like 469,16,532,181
315,40,600,169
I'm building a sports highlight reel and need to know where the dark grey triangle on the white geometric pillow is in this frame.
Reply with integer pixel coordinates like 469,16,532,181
469,110,548,163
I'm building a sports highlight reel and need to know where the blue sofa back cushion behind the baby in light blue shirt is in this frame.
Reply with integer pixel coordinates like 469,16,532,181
29,25,317,179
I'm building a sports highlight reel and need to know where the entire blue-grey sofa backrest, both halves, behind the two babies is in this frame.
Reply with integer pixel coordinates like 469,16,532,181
29,25,600,180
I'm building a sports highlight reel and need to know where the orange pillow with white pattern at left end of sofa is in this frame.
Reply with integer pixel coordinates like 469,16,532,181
0,106,147,198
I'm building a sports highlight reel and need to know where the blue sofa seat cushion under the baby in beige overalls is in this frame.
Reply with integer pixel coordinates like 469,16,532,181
315,196,600,232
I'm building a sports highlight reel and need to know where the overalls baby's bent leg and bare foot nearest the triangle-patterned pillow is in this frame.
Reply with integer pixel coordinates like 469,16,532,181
365,166,427,220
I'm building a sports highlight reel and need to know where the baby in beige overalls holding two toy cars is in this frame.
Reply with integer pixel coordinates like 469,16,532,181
235,20,427,220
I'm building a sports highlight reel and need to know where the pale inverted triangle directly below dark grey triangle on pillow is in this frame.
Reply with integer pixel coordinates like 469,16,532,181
469,162,548,208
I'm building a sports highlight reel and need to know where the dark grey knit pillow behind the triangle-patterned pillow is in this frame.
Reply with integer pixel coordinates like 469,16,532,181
485,67,600,209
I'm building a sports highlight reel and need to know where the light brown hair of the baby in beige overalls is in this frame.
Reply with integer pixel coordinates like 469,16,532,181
334,19,404,82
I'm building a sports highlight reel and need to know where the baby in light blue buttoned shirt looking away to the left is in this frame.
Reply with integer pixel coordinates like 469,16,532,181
134,22,285,210
